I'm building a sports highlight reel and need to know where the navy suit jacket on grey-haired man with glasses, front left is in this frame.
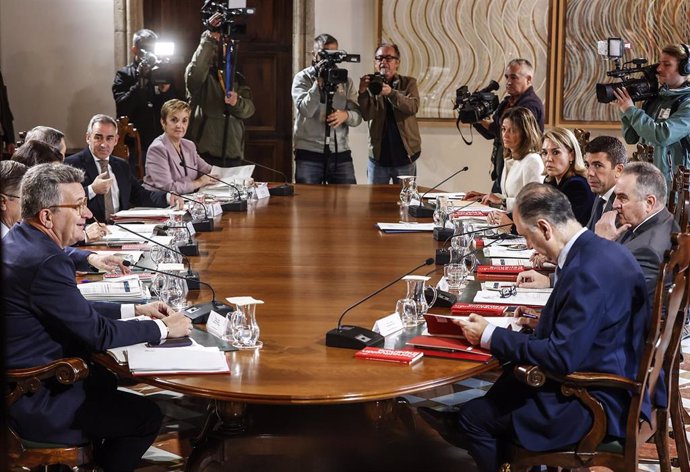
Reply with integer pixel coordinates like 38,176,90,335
2,223,161,444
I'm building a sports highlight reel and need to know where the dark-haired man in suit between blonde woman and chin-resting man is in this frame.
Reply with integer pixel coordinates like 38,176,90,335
584,136,628,231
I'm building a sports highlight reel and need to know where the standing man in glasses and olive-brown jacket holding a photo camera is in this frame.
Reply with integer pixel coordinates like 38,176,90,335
357,43,422,184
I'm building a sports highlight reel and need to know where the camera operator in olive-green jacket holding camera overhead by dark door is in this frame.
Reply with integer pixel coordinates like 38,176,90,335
185,13,256,167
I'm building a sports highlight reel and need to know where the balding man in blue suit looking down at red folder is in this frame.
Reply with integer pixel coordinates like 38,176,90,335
420,183,650,472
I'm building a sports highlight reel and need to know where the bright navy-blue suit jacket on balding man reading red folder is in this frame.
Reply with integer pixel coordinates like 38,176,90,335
487,231,650,451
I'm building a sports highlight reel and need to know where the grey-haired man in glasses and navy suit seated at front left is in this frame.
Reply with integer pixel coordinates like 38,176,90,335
2,164,191,471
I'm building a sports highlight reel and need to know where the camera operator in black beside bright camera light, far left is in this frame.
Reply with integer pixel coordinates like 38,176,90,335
113,29,181,171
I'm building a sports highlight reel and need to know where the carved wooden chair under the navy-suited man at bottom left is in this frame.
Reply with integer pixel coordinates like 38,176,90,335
5,358,93,470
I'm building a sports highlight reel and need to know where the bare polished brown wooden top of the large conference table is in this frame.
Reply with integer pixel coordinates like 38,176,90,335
101,185,497,404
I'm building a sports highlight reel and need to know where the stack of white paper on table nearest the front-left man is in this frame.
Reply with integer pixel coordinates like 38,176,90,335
127,343,230,375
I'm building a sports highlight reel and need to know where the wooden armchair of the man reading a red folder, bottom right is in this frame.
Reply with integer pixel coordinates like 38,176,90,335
501,233,690,472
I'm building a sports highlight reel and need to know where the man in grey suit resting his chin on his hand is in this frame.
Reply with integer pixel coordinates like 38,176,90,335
596,162,680,299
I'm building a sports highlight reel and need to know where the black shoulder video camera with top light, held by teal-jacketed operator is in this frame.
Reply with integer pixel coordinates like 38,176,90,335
597,38,659,103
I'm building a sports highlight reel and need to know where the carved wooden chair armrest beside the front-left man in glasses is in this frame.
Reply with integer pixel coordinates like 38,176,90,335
6,357,89,405
